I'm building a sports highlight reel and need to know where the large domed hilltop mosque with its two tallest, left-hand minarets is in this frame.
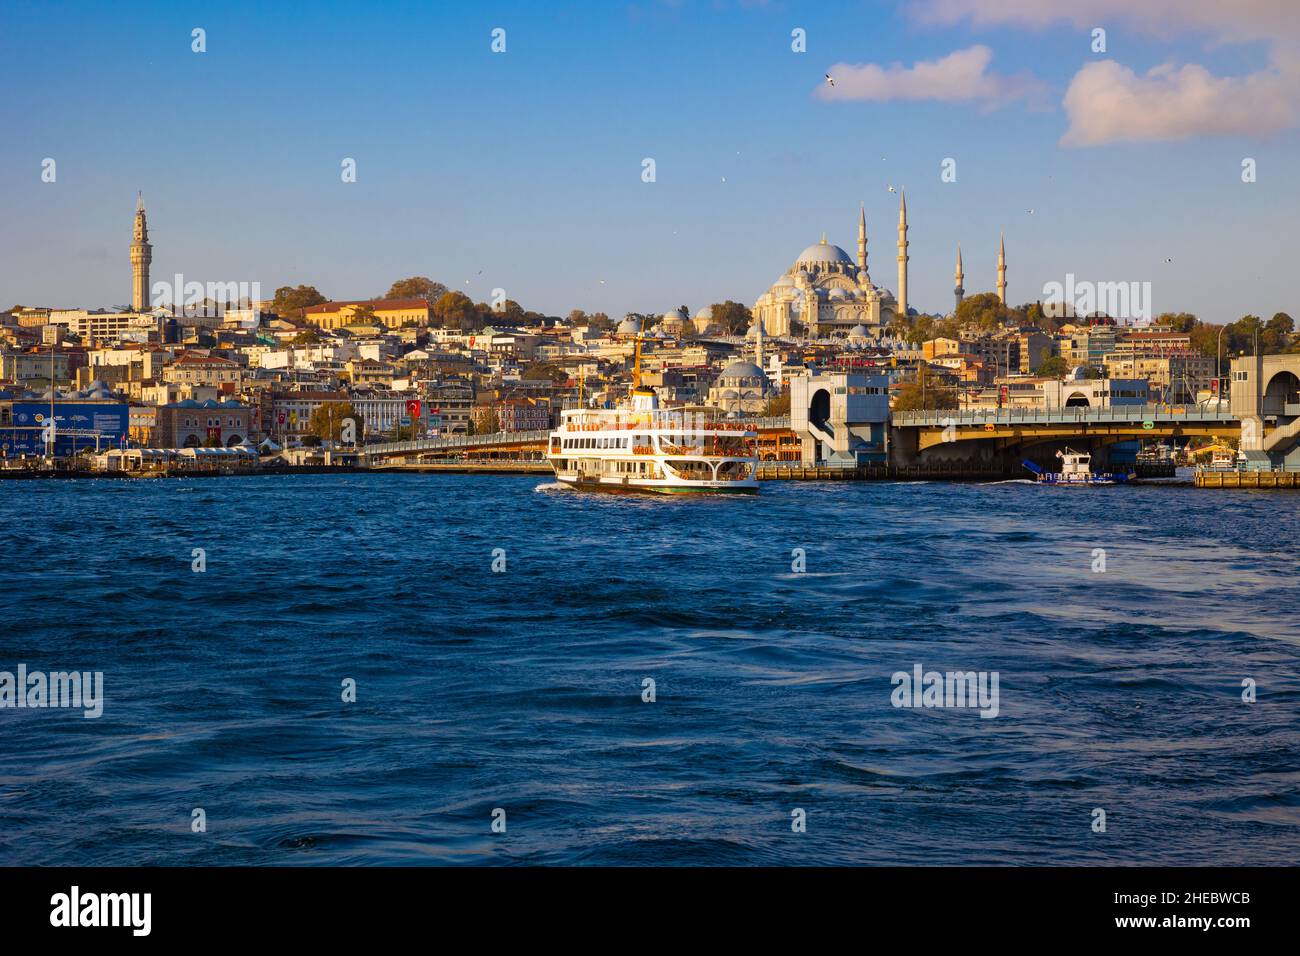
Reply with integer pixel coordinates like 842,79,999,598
753,195,909,338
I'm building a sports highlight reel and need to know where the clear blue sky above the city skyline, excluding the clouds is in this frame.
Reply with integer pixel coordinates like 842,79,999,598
0,0,1300,321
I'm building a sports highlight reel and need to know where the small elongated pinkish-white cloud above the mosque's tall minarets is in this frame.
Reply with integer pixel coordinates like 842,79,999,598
816,46,1041,107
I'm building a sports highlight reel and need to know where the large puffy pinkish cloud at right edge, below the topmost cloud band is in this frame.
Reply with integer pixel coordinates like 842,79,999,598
1061,60,1300,146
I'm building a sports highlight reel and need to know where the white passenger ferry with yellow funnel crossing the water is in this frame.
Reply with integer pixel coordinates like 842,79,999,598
546,339,758,494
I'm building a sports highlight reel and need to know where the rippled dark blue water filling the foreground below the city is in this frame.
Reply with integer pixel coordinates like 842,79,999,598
0,475,1300,865
